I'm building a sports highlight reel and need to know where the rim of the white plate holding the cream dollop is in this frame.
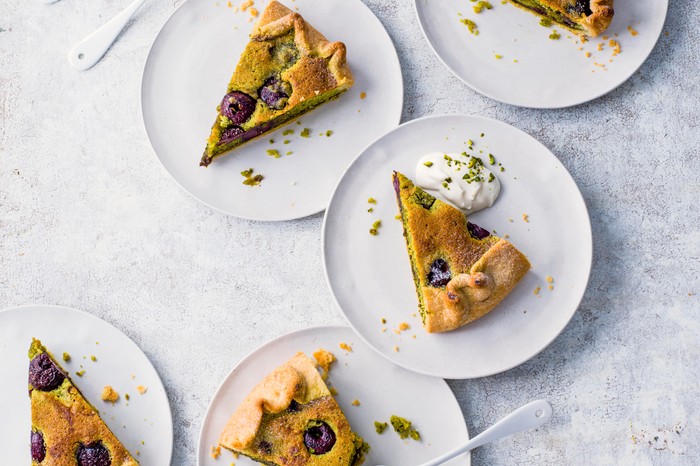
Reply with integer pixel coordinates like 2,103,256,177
321,113,593,380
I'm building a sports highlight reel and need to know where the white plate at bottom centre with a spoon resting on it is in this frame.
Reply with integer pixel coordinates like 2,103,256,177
197,327,470,466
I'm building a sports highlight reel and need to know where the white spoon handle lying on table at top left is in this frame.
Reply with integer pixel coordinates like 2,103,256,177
68,0,146,71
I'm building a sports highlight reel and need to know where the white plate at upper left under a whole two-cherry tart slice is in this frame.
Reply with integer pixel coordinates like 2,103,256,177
141,0,403,220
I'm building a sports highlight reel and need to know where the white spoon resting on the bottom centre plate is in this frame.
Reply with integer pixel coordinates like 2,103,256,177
377,400,552,466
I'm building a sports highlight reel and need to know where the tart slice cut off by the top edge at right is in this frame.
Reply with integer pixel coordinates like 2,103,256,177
509,0,615,37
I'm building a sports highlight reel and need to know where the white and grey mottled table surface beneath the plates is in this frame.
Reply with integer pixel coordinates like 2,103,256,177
0,0,700,466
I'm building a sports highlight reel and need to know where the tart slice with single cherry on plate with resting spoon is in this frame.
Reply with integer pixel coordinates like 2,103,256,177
219,353,365,466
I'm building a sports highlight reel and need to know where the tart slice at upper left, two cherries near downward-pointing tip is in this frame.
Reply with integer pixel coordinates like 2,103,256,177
200,0,353,166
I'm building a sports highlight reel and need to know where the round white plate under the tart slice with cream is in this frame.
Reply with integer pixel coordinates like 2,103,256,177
323,115,592,379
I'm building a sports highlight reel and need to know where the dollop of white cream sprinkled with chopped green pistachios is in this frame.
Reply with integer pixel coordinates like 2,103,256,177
416,152,501,214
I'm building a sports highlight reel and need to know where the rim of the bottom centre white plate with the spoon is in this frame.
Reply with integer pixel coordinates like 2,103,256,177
196,324,472,466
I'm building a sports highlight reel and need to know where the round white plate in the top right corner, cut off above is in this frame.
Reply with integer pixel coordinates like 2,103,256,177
415,0,668,108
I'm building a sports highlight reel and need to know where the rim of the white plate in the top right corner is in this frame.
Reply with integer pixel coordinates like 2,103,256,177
412,0,669,109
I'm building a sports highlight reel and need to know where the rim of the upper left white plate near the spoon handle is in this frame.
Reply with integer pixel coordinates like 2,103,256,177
139,0,406,223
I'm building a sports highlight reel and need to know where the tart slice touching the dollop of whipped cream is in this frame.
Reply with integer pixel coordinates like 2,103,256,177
393,172,530,333
